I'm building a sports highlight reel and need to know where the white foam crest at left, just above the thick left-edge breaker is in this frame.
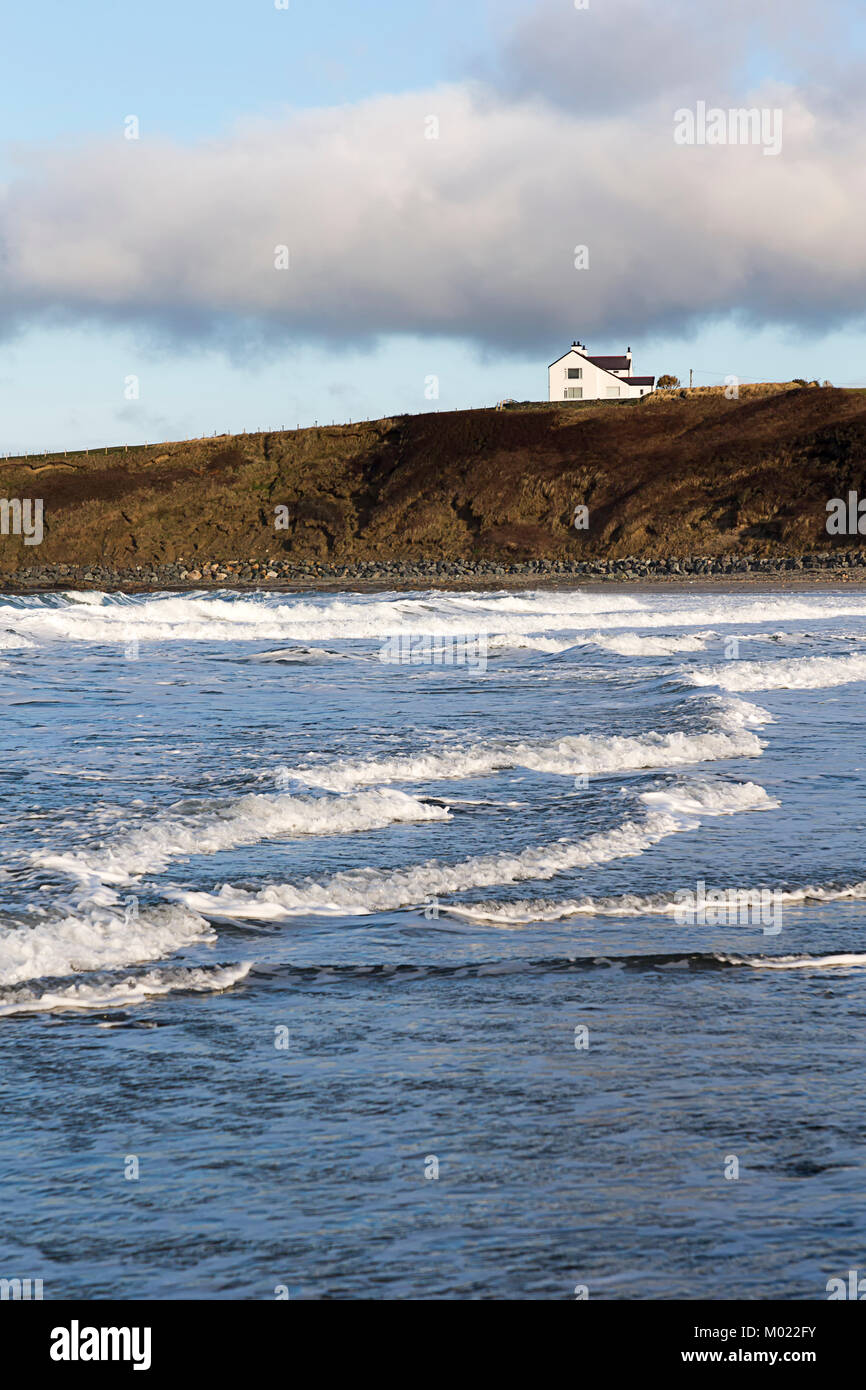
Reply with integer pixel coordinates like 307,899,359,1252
32,788,450,884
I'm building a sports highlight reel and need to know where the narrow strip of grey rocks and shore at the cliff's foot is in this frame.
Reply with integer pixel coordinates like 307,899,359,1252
0,552,866,596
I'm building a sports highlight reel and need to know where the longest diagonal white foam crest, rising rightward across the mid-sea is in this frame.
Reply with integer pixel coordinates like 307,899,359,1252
171,783,777,922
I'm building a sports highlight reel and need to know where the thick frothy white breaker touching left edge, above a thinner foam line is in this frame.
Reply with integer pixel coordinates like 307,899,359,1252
0,904,214,986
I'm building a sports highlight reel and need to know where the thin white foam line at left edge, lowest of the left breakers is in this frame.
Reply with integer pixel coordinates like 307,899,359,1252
0,960,252,1017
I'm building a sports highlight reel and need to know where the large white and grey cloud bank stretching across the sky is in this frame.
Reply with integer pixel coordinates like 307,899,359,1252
0,0,866,352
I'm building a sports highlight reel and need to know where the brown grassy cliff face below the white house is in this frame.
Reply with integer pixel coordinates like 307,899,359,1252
0,388,866,573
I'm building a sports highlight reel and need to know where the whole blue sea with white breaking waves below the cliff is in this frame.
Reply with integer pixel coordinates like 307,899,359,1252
0,585,866,1301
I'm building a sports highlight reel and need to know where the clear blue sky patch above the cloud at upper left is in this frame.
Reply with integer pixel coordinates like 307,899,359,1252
0,0,505,142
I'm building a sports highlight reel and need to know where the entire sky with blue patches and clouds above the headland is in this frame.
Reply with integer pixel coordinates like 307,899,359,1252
0,0,866,453
